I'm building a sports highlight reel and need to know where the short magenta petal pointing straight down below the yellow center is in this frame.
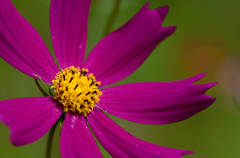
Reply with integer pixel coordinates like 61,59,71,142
60,113,103,158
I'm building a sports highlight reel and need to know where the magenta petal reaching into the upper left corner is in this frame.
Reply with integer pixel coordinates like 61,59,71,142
0,0,59,83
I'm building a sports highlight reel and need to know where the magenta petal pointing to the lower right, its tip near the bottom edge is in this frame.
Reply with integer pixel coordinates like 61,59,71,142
88,108,194,158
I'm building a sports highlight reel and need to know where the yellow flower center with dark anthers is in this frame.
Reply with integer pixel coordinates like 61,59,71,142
51,66,102,116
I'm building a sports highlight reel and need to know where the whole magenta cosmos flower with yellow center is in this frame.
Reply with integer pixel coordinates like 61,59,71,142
0,0,216,158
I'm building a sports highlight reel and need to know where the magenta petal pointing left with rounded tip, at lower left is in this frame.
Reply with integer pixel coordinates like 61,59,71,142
0,97,63,146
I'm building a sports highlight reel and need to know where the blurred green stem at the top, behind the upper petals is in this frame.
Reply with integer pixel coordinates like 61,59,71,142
103,0,121,37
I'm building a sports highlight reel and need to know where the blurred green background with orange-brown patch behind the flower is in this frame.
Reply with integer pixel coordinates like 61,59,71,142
0,0,240,158
